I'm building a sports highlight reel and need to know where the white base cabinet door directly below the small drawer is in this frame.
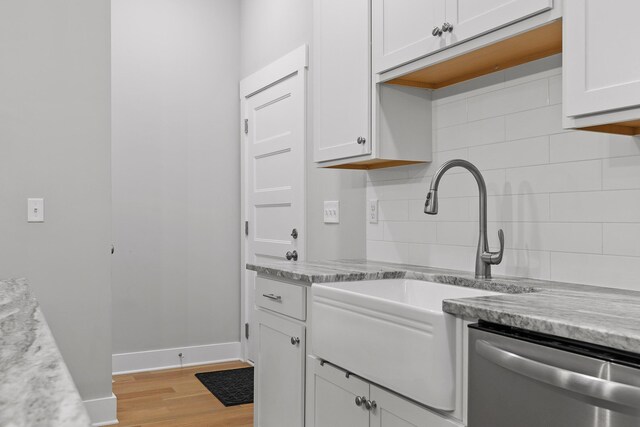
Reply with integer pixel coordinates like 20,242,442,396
254,310,305,427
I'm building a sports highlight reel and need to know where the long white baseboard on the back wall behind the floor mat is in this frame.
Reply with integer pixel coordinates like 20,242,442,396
111,342,242,375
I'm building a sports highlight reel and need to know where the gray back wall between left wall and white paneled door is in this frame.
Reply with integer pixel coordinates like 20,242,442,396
112,0,240,353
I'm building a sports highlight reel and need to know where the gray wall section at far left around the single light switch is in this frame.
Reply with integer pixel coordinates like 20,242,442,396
0,0,111,399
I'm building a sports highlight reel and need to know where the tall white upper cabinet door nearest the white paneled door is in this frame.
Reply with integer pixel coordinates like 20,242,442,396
311,0,371,162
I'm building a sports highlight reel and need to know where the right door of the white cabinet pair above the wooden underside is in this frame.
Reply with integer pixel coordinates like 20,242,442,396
445,0,553,45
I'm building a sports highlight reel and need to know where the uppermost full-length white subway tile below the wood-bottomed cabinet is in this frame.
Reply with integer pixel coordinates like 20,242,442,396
459,79,549,121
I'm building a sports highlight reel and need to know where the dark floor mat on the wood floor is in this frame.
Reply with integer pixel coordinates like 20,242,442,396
196,368,253,406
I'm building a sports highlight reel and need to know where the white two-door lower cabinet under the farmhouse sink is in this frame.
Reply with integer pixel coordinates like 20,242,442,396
307,357,462,427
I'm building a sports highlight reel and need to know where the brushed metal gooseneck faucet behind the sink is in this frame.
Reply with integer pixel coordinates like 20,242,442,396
424,159,504,279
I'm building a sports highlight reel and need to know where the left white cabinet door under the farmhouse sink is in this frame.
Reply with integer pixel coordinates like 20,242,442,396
312,359,369,427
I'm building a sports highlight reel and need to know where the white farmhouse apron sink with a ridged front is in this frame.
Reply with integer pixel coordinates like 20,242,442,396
311,279,498,411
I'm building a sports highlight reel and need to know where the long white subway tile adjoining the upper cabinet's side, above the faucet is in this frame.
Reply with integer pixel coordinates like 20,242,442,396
436,117,505,151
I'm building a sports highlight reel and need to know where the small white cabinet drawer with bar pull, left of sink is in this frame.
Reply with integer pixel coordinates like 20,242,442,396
256,277,307,320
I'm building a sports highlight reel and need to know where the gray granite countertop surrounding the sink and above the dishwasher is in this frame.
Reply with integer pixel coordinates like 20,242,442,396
247,260,640,354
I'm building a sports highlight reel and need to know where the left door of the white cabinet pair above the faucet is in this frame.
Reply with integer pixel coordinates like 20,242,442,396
372,0,445,73
